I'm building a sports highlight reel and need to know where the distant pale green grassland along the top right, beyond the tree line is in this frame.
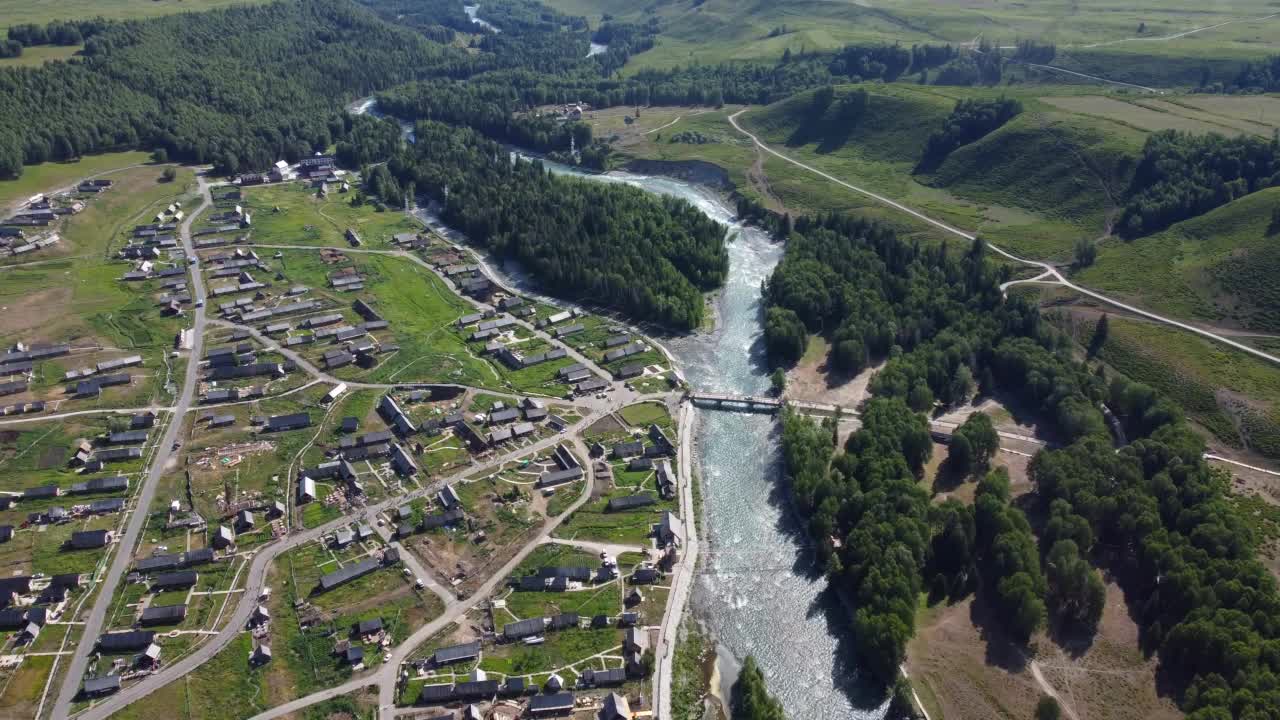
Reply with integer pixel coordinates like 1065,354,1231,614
548,0,1280,85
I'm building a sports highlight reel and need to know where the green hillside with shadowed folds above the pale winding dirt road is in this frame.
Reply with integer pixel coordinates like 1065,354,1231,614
742,85,1146,260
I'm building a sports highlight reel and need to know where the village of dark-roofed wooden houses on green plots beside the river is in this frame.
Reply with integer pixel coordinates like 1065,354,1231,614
0,151,684,719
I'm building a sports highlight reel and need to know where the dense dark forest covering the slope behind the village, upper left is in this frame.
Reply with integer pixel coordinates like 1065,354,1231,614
0,0,467,176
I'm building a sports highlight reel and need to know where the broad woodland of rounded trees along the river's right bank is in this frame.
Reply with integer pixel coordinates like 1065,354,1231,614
768,210,1280,720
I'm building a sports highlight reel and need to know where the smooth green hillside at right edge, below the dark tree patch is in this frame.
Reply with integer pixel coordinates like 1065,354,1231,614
1078,187,1280,333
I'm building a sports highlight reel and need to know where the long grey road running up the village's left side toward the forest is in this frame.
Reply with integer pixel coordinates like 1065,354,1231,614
52,177,214,720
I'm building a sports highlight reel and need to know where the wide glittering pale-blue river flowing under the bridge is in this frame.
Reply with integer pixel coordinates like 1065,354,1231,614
364,98,884,720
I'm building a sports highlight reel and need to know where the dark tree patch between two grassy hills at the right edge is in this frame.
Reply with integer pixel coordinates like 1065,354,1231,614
1117,131,1280,237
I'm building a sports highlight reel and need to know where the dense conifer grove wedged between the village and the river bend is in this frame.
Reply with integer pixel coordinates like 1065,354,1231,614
373,122,728,331
